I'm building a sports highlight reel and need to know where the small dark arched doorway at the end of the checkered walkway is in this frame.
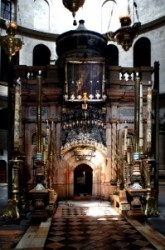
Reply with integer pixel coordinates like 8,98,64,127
74,164,93,195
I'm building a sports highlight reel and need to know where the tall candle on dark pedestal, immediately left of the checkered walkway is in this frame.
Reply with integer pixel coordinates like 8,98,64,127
29,72,56,220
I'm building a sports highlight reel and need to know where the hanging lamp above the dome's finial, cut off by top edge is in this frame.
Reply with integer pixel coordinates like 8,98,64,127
63,0,85,25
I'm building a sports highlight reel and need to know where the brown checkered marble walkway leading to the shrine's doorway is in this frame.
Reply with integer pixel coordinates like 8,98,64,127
44,202,157,250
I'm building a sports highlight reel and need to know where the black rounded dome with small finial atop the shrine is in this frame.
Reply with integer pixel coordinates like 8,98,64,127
56,20,107,59
